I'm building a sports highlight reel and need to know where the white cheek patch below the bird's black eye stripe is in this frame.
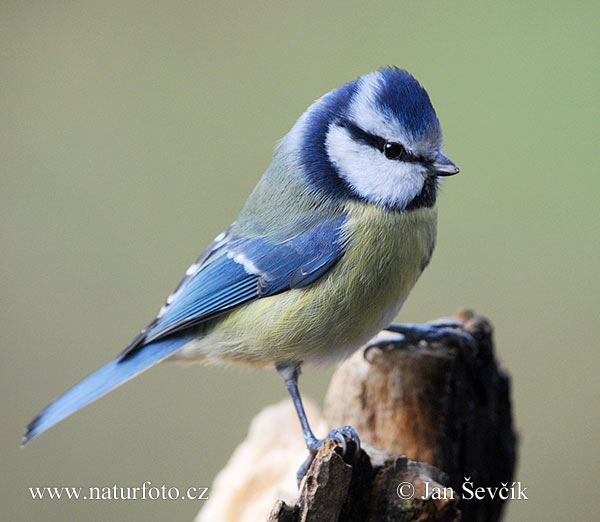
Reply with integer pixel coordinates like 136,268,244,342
326,126,425,208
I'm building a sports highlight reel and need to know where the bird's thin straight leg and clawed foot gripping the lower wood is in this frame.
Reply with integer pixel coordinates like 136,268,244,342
275,362,360,484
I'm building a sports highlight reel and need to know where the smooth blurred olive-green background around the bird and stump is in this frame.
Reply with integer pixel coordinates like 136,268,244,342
0,0,600,521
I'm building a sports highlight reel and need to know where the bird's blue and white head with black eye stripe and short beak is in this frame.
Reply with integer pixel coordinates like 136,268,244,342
283,67,459,210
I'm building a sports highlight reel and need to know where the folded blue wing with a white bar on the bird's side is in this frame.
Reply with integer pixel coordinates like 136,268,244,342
138,217,345,346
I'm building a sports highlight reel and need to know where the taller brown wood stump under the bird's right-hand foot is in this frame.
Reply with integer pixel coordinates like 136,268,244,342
325,310,516,521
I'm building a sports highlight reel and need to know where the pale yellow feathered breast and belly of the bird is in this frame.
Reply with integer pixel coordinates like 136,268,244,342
174,203,436,365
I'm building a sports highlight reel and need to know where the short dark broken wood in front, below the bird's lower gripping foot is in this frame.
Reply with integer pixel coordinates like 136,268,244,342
268,441,460,522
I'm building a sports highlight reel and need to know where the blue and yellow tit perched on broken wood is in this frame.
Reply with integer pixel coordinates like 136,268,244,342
23,66,467,480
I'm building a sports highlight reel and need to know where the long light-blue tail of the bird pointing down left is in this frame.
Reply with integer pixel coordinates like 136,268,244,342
23,337,189,446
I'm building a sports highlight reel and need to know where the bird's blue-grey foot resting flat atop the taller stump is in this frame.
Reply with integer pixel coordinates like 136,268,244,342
364,321,475,355
